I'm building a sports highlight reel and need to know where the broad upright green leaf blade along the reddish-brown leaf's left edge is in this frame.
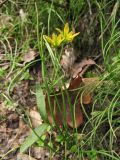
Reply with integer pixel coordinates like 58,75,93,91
36,84,48,122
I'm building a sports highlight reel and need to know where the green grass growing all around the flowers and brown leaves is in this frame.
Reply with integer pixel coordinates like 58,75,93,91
0,0,120,160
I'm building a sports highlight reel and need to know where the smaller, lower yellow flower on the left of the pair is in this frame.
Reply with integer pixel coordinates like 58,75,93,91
45,33,63,47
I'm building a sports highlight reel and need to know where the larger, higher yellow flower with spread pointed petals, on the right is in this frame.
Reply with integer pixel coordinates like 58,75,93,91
56,23,80,42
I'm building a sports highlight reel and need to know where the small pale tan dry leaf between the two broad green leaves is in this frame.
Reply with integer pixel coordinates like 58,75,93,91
30,110,42,128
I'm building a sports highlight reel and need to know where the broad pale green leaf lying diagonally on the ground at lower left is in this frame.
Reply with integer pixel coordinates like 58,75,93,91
20,123,49,153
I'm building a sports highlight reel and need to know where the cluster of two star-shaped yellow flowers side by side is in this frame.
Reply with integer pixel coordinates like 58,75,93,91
45,23,80,47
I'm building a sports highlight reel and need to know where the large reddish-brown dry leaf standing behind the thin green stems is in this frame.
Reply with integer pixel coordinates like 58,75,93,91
46,92,83,128
